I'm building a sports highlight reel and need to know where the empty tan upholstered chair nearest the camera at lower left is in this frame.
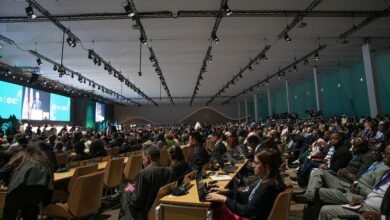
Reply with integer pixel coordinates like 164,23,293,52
41,171,104,219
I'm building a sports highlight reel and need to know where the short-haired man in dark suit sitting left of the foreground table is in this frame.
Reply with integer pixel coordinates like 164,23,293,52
119,144,171,220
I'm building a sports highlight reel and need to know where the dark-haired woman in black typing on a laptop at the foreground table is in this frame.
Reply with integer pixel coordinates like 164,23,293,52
206,149,285,220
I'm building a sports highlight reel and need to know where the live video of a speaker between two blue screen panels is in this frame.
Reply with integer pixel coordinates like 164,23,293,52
22,87,50,120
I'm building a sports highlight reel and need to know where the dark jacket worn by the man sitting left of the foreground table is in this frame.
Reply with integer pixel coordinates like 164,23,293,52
119,163,171,220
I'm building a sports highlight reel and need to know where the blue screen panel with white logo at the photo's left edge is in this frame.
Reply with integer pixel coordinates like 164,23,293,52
0,81,23,119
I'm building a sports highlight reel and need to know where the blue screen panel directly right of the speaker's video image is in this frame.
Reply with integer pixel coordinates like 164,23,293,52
50,93,70,121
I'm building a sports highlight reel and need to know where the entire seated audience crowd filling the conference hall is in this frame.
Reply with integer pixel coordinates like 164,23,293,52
0,115,390,220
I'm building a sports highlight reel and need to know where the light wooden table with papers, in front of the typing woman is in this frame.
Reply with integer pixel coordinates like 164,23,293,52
155,161,247,220
